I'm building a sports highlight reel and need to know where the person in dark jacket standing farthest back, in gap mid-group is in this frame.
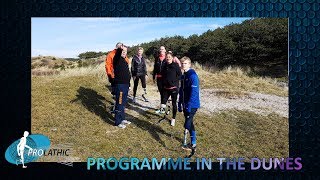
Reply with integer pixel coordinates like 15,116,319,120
131,47,148,103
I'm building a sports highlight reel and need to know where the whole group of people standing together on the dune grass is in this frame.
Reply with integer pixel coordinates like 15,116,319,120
105,43,200,150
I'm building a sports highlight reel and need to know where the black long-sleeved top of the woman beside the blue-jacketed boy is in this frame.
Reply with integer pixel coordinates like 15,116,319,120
162,62,181,89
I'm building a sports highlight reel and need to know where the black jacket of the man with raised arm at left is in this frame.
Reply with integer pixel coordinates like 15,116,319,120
113,48,131,84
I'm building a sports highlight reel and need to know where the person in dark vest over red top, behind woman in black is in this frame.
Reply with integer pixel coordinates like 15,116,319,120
153,46,166,111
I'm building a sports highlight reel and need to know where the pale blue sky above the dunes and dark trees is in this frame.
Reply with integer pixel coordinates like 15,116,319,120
31,18,248,58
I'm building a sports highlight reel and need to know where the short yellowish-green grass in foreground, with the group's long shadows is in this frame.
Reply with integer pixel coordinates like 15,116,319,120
32,72,288,161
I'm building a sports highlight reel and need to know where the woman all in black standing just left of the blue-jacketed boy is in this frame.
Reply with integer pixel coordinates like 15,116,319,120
157,52,181,126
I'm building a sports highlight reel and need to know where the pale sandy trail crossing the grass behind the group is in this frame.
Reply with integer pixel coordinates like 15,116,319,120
125,86,289,117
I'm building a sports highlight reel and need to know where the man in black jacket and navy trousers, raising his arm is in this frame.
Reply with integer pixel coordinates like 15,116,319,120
113,45,131,129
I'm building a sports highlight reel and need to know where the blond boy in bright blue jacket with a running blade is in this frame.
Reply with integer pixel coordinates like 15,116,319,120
178,57,200,151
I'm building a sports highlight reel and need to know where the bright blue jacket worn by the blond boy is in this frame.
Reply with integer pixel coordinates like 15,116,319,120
179,69,200,112
